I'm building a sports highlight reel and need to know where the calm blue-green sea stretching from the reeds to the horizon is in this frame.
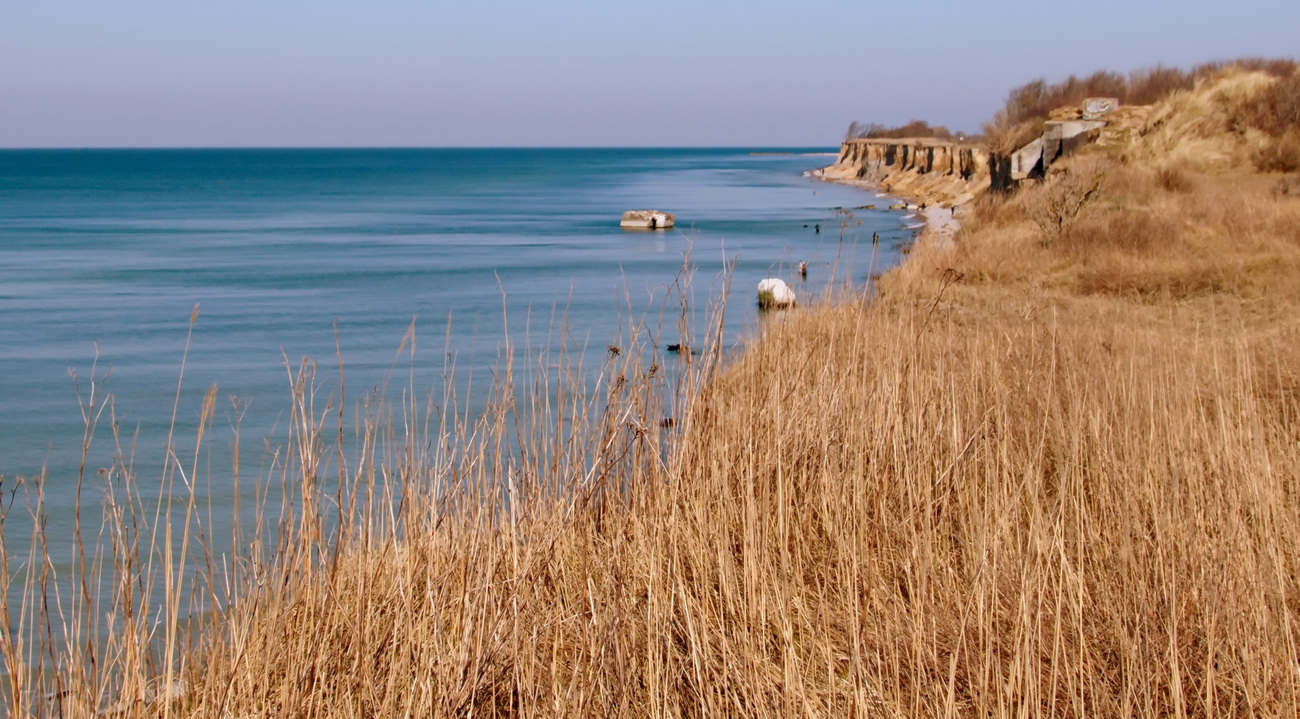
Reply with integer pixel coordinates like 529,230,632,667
0,148,915,551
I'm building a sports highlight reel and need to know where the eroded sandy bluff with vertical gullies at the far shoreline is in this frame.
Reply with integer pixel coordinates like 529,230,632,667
816,138,989,205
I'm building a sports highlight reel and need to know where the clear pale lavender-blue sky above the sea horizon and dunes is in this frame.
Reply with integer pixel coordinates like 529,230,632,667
0,0,1300,147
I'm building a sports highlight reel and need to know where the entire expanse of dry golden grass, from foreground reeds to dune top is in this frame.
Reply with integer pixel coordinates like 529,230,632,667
0,64,1300,718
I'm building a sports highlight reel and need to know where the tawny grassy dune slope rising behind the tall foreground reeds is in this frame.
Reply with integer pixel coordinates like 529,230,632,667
885,73,1300,312
